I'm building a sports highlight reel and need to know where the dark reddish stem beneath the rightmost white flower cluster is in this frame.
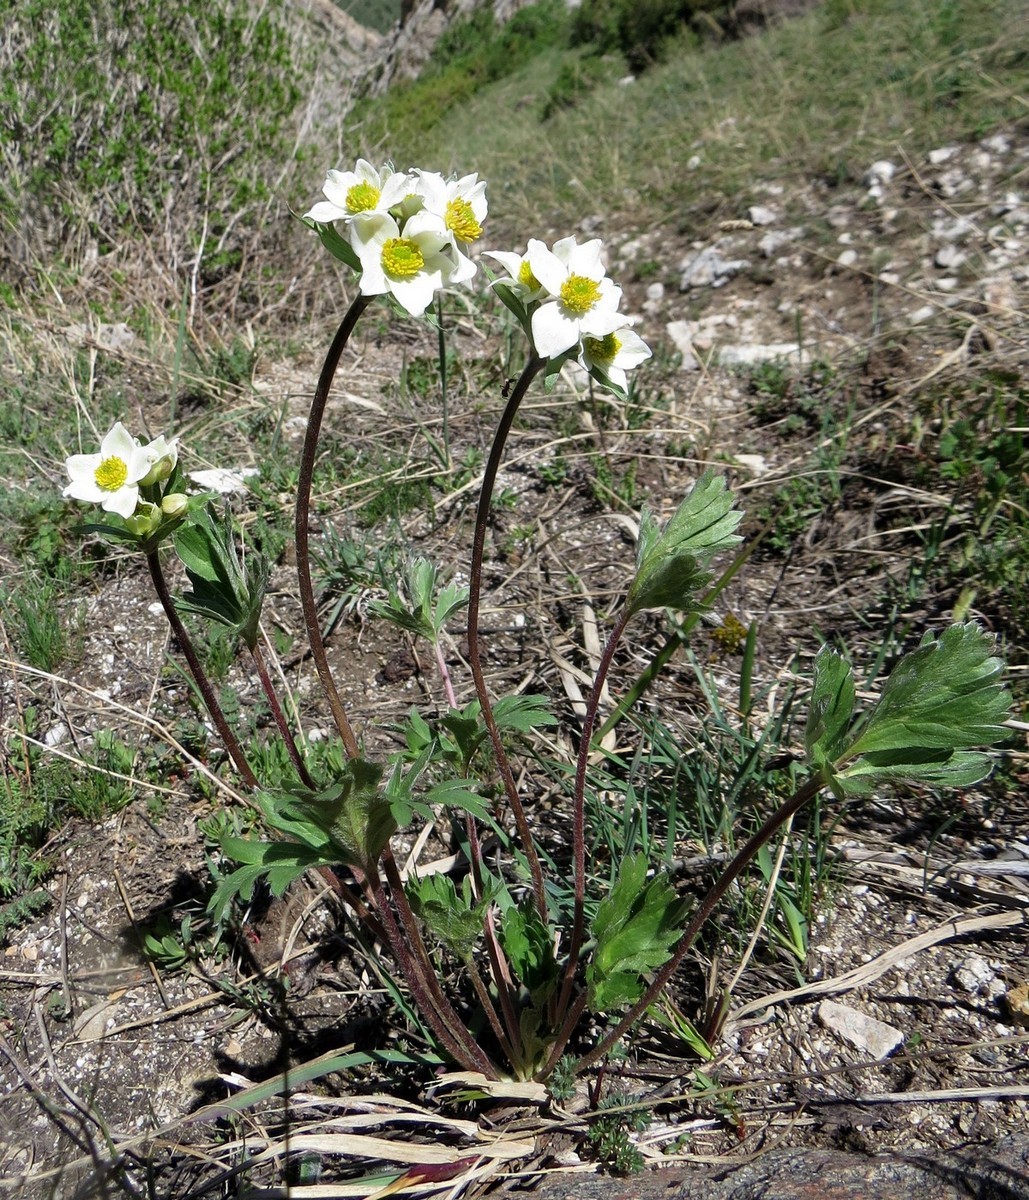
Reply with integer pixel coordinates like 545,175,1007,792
468,354,547,922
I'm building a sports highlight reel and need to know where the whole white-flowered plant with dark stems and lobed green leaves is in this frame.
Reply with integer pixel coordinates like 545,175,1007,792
65,160,1010,1080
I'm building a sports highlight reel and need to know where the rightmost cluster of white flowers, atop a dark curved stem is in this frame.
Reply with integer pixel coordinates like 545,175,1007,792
487,238,650,391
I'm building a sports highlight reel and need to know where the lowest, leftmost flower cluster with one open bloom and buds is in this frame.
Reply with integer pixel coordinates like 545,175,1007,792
64,421,189,541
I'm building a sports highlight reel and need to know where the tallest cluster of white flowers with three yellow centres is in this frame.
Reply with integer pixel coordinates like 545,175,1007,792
305,158,487,317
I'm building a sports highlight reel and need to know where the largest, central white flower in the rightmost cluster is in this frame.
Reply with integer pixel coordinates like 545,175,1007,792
525,238,625,359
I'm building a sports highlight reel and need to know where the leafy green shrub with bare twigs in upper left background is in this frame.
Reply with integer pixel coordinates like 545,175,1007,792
0,0,302,297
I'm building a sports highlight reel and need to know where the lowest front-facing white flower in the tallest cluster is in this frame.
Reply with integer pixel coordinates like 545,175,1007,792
350,211,453,317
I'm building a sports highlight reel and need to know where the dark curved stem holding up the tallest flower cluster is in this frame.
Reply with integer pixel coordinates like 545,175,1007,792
296,295,372,758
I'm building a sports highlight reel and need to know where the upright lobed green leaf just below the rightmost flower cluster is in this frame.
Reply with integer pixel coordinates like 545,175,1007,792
626,472,742,613
